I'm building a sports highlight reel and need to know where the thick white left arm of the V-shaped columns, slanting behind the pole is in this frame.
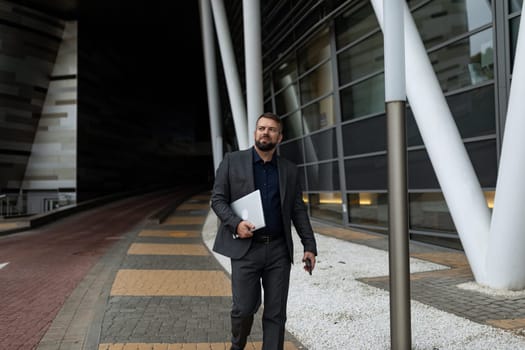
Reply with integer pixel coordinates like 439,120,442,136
371,0,490,281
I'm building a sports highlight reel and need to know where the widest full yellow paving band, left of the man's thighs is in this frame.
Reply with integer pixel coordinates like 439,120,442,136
111,269,231,296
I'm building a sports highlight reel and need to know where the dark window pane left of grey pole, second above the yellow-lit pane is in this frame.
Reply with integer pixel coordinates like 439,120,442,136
343,115,386,156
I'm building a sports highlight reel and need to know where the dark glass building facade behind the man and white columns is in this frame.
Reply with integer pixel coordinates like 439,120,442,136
220,0,523,249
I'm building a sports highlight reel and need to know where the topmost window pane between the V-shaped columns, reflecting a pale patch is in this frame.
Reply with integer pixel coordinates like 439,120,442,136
412,0,492,49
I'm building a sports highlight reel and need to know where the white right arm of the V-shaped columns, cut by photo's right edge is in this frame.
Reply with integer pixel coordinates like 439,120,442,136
485,7,525,290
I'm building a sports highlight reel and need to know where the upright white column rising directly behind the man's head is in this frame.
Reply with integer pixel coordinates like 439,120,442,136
242,0,264,145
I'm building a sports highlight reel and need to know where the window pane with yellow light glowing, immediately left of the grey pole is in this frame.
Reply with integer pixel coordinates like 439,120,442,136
348,192,388,226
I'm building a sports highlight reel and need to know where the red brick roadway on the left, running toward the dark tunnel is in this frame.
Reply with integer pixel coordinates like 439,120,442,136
0,193,195,350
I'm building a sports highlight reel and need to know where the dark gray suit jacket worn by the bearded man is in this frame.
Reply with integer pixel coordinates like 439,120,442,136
211,148,317,261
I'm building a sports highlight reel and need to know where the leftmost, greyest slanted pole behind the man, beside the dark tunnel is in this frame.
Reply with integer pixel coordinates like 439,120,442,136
199,0,223,170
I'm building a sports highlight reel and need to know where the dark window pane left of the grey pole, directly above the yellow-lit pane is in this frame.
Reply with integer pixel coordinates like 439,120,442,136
345,155,387,191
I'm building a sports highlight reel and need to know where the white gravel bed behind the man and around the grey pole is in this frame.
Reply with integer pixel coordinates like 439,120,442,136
203,211,525,350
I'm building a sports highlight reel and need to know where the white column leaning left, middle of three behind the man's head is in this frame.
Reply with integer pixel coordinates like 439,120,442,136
211,0,249,149
